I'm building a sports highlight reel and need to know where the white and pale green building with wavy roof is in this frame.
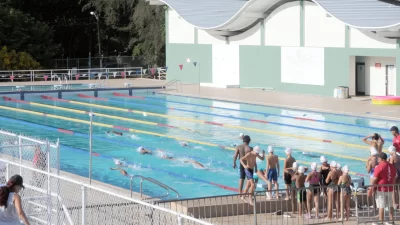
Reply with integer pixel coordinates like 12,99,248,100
148,0,400,96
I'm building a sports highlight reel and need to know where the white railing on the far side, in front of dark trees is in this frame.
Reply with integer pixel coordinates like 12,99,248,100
0,67,144,82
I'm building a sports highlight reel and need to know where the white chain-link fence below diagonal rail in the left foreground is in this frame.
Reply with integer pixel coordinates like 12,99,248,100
0,159,211,225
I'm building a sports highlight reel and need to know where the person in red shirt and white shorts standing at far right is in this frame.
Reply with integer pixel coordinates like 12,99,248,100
371,153,397,225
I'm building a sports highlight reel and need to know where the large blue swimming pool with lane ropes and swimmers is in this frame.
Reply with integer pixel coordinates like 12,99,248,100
0,90,395,198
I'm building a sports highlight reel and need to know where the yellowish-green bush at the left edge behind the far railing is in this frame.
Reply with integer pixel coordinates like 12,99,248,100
0,46,40,70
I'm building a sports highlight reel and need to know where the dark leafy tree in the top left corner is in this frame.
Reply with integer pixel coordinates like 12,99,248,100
0,4,59,64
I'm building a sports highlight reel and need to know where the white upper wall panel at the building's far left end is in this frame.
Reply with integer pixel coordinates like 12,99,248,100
168,9,194,44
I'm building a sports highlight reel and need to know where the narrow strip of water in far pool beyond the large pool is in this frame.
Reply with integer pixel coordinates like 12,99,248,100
0,83,89,92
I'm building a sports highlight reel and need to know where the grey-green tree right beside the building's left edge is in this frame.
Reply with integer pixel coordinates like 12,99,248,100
83,0,165,65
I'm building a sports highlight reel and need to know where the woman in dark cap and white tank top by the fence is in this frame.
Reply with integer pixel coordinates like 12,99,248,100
0,175,29,225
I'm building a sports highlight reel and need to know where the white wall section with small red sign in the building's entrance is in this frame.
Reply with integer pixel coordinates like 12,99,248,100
365,57,396,96
